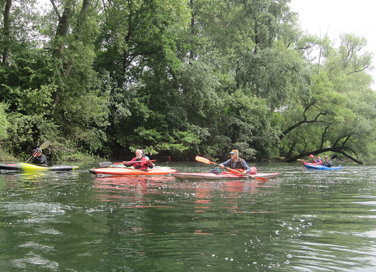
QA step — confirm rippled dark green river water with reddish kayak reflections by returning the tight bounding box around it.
[0,162,376,272]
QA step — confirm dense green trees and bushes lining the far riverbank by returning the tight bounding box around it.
[0,0,376,163]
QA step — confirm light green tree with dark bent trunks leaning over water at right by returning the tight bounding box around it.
[280,35,376,163]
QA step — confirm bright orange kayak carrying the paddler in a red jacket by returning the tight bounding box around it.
[89,167,176,176]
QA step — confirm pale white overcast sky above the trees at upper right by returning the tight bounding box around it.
[290,0,376,90]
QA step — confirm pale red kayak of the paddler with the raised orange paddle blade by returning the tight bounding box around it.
[171,172,280,180]
